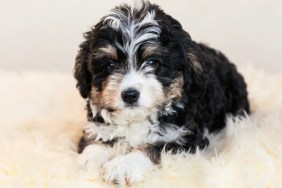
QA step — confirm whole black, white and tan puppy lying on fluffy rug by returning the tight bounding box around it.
[74,1,249,185]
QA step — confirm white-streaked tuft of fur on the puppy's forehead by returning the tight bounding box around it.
[105,3,161,66]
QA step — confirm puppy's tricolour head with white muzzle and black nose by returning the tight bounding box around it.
[74,2,199,120]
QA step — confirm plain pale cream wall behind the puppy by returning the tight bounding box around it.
[0,0,282,72]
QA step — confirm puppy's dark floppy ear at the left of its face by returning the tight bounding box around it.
[74,34,92,98]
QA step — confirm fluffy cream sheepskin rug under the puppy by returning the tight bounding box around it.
[0,67,282,188]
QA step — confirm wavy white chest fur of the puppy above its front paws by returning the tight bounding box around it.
[85,120,189,148]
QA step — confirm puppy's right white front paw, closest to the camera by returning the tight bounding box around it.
[103,151,153,185]
